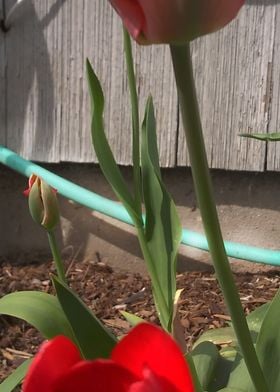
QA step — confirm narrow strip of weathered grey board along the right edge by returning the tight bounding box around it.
[266,4,280,171]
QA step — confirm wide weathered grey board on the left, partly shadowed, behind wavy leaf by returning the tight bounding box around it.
[2,0,177,166]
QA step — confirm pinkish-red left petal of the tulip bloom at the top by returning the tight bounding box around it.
[111,0,145,40]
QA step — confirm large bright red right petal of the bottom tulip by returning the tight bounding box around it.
[112,323,194,392]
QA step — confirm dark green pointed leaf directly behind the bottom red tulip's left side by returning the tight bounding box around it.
[52,276,117,359]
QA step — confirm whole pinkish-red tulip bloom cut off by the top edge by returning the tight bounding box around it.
[110,0,244,44]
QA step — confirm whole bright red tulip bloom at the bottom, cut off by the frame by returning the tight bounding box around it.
[22,323,194,392]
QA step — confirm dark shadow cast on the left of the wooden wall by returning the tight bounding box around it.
[5,0,65,160]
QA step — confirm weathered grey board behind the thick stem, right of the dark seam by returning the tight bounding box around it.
[178,4,275,171]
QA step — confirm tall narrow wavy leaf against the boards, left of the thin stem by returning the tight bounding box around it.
[86,60,142,224]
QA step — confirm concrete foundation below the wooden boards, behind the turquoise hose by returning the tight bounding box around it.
[0,164,280,273]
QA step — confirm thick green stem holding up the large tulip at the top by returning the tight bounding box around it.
[170,44,268,392]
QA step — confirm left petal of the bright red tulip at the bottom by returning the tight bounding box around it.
[22,336,81,392]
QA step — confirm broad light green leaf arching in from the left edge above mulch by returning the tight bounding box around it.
[0,291,73,340]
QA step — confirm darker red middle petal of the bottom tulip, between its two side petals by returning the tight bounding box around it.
[52,359,138,392]
